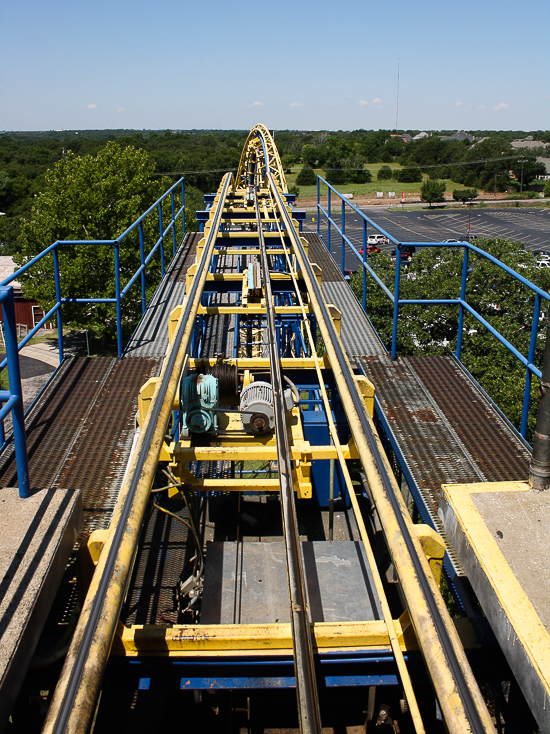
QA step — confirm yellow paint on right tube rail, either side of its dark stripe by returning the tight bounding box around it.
[270,178,494,734]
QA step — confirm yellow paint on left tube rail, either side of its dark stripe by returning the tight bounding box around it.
[43,174,231,734]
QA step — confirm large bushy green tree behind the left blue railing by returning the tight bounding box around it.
[15,142,169,342]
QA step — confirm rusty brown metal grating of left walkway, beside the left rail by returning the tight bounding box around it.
[0,357,159,540]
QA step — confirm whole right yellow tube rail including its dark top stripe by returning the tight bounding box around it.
[268,175,495,734]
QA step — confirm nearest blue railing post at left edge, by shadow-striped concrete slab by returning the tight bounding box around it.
[0,286,31,497]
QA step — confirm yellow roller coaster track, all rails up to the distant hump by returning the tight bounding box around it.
[44,125,494,734]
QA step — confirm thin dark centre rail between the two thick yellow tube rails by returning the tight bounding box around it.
[254,191,321,734]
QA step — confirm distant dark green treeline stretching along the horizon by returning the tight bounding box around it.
[0,130,550,254]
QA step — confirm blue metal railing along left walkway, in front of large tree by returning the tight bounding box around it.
[0,178,185,362]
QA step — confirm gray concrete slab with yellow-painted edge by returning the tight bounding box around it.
[439,482,550,734]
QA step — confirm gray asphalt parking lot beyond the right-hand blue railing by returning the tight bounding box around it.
[304,207,550,270]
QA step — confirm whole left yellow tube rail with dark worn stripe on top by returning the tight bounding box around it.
[43,174,232,734]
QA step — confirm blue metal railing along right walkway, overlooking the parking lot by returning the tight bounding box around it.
[317,176,550,438]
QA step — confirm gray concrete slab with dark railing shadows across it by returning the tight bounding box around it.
[0,487,82,731]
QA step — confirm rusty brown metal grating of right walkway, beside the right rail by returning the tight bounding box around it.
[361,356,529,525]
